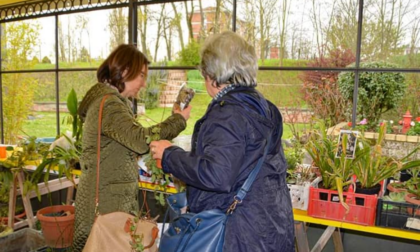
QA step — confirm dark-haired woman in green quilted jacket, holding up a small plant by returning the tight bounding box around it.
[73,44,191,251]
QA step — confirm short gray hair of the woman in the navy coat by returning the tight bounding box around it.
[199,31,258,87]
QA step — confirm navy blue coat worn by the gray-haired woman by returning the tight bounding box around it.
[162,87,294,252]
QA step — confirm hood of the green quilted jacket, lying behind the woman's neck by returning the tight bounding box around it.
[78,83,122,122]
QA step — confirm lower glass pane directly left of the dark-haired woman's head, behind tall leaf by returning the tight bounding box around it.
[59,71,97,136]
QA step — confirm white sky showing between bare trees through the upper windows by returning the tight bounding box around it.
[15,0,420,63]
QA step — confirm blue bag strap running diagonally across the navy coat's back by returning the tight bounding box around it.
[227,131,271,214]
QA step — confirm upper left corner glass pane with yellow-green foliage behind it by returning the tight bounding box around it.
[1,17,55,70]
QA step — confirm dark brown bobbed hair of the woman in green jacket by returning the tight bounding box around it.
[96,44,150,93]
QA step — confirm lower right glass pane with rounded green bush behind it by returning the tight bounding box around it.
[357,72,420,133]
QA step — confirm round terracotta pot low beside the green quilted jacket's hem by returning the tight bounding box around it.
[36,205,75,248]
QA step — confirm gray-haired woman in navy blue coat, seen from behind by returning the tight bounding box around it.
[150,31,294,252]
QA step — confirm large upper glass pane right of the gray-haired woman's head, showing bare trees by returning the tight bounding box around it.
[236,0,358,67]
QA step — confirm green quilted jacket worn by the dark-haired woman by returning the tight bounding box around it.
[73,83,186,251]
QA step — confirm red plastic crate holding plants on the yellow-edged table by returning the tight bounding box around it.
[308,187,378,226]
